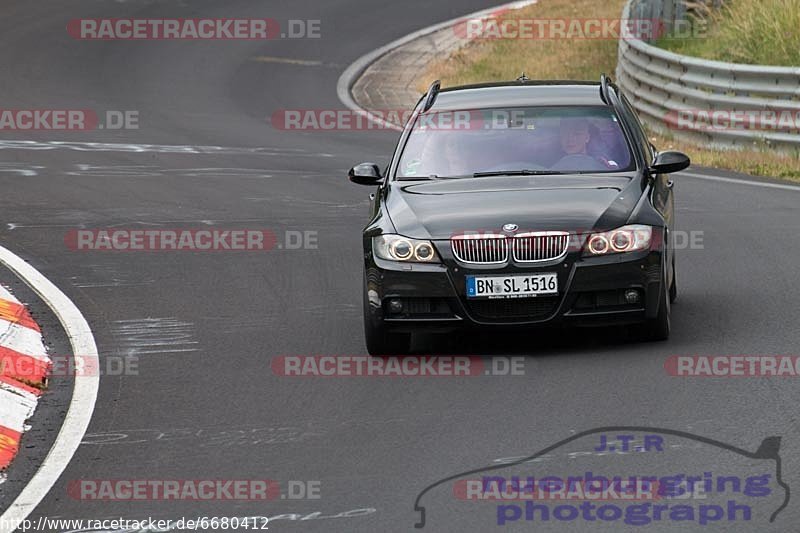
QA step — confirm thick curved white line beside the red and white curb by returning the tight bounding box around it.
[0,246,100,533]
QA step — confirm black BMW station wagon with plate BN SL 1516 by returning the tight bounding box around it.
[349,76,690,355]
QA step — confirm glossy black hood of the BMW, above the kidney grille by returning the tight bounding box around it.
[386,174,641,239]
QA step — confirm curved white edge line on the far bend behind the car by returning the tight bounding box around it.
[336,0,538,131]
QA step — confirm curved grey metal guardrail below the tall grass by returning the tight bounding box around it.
[617,0,800,151]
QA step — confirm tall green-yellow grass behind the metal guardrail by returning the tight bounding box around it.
[657,0,800,67]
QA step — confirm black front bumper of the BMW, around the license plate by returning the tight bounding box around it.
[365,238,666,331]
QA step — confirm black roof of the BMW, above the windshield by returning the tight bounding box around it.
[431,81,606,112]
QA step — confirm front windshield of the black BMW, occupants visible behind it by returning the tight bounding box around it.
[397,106,635,179]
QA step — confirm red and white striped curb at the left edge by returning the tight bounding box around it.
[0,286,51,483]
